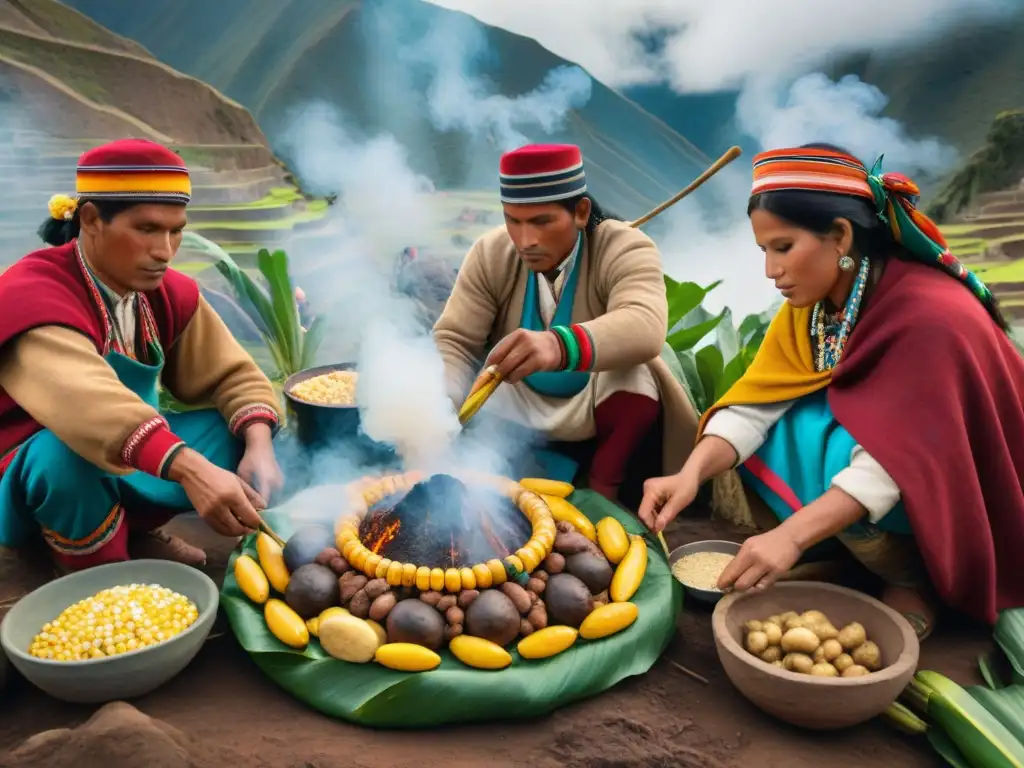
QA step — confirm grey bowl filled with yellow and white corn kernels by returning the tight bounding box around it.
[0,560,219,703]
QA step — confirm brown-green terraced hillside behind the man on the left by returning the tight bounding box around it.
[0,0,326,267]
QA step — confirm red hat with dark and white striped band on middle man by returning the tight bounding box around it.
[500,144,587,205]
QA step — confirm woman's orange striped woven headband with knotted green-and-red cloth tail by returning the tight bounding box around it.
[751,148,995,309]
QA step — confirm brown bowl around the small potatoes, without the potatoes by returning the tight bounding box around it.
[712,582,921,730]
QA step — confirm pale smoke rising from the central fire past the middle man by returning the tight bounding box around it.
[264,4,591,507]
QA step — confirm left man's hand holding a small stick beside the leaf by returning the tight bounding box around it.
[168,447,266,537]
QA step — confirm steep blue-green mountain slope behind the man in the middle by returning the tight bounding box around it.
[59,0,710,217]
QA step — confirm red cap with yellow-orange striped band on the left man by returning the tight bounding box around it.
[76,138,191,203]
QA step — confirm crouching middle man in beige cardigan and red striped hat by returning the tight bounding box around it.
[434,145,696,500]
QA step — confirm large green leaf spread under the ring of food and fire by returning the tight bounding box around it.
[221,490,682,729]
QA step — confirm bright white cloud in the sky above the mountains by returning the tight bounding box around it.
[421,0,1020,92]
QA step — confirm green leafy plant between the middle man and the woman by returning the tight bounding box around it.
[665,276,773,413]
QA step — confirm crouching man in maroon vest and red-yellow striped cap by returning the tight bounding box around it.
[0,139,282,570]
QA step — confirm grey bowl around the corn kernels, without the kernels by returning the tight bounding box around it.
[0,560,219,703]
